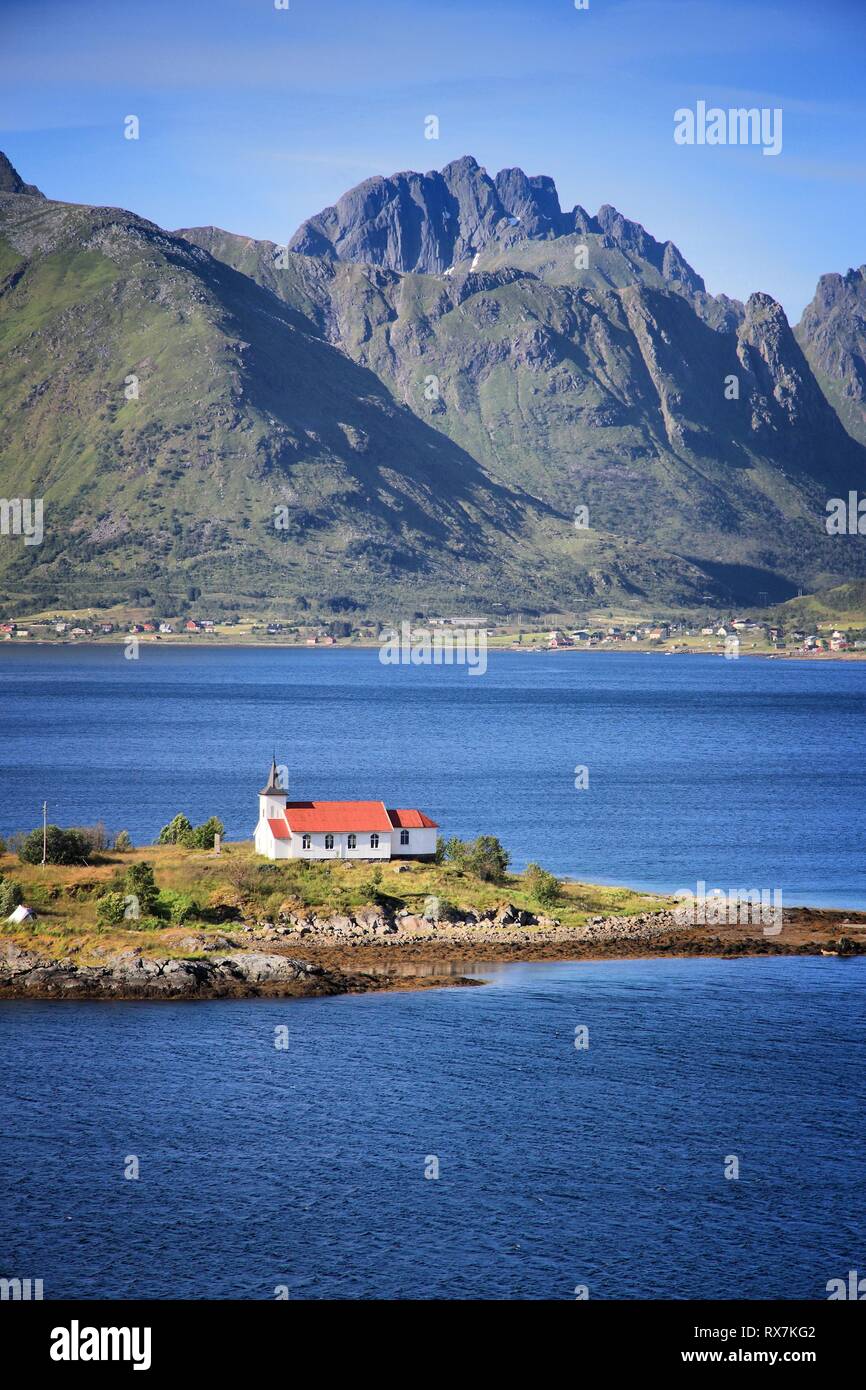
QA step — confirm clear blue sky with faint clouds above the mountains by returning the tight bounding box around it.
[0,0,866,321]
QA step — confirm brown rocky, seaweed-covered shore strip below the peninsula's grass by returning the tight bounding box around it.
[0,904,866,999]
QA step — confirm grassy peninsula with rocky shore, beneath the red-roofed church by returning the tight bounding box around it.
[0,842,866,998]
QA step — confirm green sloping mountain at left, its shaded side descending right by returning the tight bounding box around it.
[0,152,705,614]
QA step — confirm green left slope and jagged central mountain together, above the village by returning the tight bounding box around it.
[0,148,866,617]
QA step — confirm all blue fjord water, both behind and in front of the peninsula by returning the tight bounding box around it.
[0,646,866,1298]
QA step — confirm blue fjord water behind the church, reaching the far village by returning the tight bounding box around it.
[0,642,866,908]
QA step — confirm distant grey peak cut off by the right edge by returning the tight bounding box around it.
[795,265,866,443]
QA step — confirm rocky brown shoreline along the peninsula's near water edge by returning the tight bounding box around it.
[0,909,866,1002]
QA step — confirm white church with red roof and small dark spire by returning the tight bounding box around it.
[256,760,439,859]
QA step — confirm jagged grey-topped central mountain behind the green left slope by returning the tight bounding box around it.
[182,160,866,602]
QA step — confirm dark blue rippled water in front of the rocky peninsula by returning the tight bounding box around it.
[0,958,866,1300]
